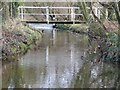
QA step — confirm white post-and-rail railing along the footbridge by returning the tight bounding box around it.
[18,6,102,23]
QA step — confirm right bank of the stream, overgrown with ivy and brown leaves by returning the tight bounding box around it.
[58,21,120,63]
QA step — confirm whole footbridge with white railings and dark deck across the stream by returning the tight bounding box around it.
[18,6,104,24]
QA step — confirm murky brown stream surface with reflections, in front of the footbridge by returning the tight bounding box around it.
[2,31,120,88]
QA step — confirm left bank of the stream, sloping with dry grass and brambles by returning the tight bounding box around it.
[2,20,42,62]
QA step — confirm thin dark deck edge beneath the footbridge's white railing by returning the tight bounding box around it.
[22,21,86,24]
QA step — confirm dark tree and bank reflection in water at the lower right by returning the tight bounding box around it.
[74,62,120,88]
